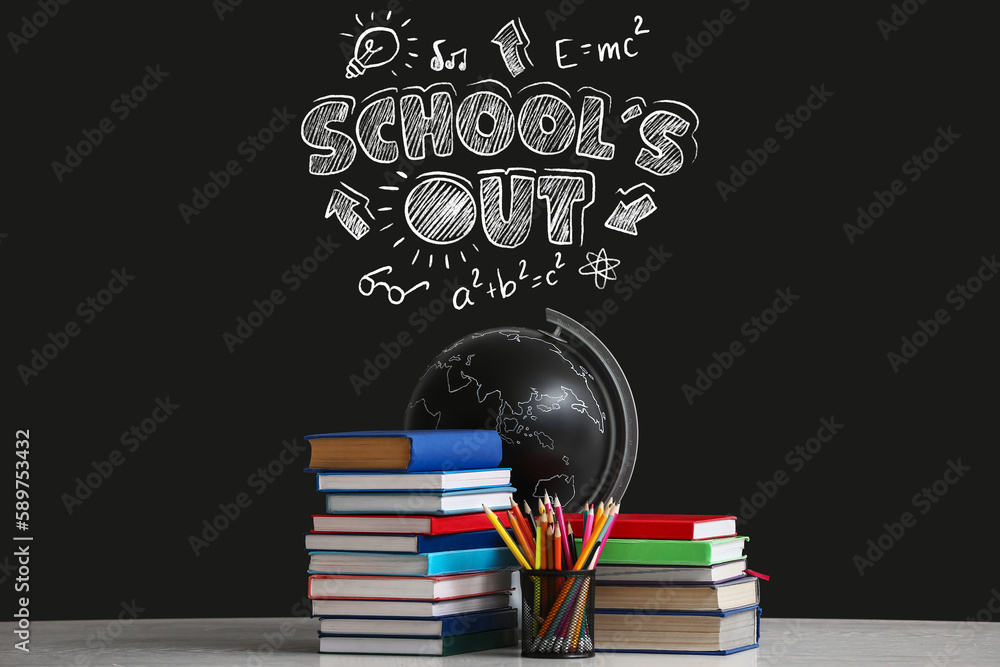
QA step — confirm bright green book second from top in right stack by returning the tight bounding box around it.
[577,536,750,567]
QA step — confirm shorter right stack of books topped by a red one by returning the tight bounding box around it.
[566,514,760,654]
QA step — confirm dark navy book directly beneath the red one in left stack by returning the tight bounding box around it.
[306,529,505,554]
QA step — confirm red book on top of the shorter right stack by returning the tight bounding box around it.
[564,514,736,540]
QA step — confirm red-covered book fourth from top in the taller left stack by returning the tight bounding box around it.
[312,512,510,535]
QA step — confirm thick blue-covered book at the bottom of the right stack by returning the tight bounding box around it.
[594,605,760,655]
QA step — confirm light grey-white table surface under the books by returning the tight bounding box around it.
[0,617,1000,667]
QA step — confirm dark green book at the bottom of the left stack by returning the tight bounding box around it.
[319,628,520,655]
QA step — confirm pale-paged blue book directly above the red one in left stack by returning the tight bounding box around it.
[325,486,516,515]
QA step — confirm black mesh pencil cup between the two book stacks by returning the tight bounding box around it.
[521,570,594,658]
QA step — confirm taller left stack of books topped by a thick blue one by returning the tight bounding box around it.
[305,430,518,655]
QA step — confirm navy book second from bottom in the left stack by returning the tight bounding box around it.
[319,607,517,637]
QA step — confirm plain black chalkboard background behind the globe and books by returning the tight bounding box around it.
[0,0,1000,620]
